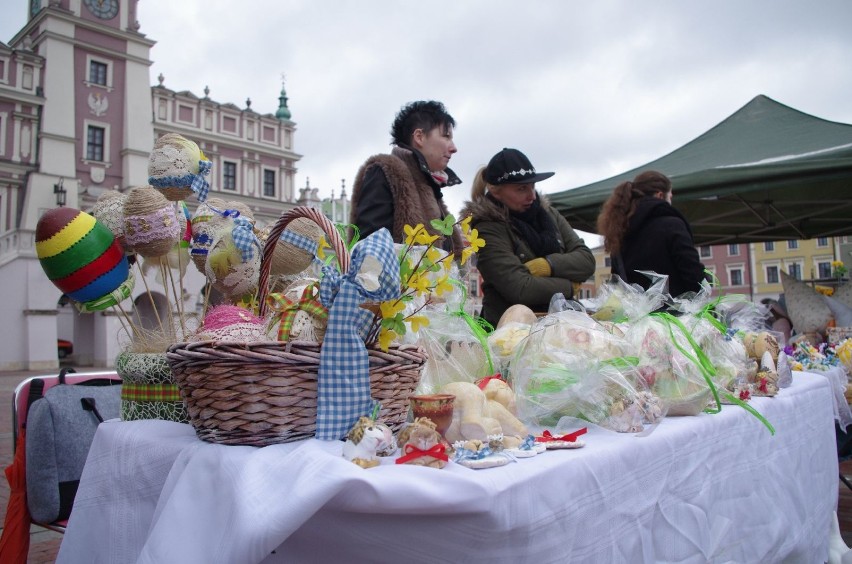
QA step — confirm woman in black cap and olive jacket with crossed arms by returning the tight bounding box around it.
[461,149,595,325]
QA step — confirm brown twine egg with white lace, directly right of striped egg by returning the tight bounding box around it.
[124,186,180,257]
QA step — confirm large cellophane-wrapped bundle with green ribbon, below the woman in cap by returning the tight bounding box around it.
[512,311,664,432]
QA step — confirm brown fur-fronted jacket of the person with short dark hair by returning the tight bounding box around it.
[350,147,464,253]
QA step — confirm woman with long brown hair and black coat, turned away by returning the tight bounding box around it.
[597,170,705,296]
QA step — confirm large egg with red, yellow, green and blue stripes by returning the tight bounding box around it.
[36,207,130,302]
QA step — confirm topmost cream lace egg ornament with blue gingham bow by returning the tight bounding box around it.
[148,133,211,202]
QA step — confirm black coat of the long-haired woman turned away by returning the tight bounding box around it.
[612,196,705,296]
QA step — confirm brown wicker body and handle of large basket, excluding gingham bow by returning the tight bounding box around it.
[166,207,426,446]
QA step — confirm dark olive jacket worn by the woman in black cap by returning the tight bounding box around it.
[461,194,595,325]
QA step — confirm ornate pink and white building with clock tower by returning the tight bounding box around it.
[0,0,304,370]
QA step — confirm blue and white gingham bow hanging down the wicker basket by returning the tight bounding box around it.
[316,229,400,441]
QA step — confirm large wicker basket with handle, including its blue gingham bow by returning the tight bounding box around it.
[166,207,426,446]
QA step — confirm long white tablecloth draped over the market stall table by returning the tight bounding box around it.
[57,372,838,564]
